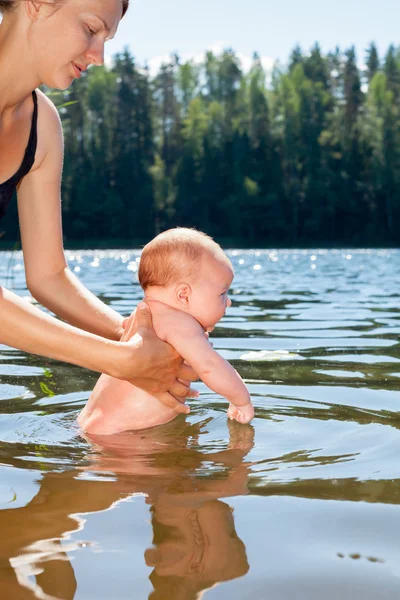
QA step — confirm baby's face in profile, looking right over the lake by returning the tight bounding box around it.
[189,256,234,329]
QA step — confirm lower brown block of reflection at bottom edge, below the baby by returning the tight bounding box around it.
[145,500,249,600]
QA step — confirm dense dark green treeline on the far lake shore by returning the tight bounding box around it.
[2,44,400,246]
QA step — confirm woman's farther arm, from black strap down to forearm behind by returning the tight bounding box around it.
[18,92,122,340]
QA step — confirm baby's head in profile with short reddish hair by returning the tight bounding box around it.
[138,227,234,329]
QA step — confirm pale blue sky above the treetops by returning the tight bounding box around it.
[106,0,400,72]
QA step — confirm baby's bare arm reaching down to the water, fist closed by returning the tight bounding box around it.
[166,315,254,423]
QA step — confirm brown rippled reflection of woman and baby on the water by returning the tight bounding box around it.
[0,422,254,600]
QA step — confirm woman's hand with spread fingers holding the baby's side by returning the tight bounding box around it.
[115,302,198,414]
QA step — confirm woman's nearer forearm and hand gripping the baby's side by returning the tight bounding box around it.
[0,287,192,412]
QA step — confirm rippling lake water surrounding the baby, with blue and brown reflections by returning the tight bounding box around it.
[0,250,400,600]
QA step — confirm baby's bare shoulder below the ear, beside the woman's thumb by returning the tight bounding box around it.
[146,299,204,341]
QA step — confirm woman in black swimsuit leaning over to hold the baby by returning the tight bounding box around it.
[0,0,196,412]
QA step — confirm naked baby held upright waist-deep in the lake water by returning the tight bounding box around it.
[78,228,254,434]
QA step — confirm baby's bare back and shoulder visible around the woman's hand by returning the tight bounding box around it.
[78,300,193,434]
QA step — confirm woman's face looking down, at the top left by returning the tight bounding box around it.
[30,0,122,90]
